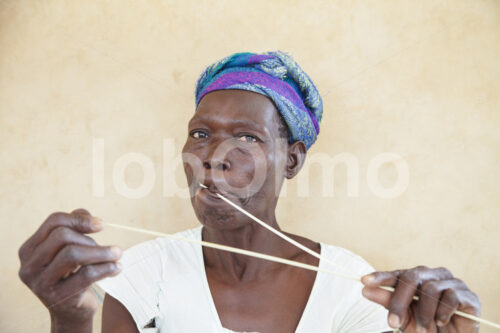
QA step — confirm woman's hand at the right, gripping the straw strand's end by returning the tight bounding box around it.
[361,266,481,333]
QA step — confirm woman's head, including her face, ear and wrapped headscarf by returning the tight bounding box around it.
[183,52,322,228]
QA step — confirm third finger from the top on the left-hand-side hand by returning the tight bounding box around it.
[43,245,122,284]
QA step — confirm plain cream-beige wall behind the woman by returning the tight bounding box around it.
[0,0,500,332]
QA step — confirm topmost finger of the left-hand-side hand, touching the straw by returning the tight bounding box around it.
[19,209,102,262]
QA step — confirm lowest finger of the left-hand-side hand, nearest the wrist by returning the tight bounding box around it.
[47,262,122,308]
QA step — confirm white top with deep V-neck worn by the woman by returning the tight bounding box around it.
[97,226,391,333]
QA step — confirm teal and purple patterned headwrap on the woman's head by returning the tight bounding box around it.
[195,51,323,149]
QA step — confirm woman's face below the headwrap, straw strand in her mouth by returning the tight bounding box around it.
[182,90,288,229]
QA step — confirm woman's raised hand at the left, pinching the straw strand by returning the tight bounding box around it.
[19,209,122,331]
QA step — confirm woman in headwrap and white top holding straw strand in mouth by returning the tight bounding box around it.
[19,52,480,332]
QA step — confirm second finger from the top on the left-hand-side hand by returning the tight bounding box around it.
[26,227,97,270]
